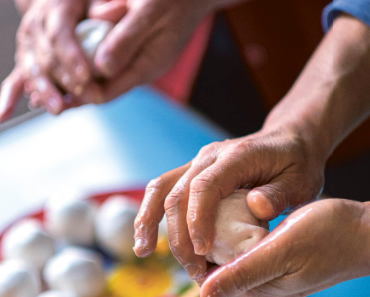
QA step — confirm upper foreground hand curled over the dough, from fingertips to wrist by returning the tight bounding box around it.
[135,129,325,279]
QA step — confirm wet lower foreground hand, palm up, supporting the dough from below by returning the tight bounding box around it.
[201,199,370,297]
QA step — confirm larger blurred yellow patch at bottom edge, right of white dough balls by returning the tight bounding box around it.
[109,263,172,297]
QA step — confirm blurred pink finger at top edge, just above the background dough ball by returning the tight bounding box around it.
[88,0,127,23]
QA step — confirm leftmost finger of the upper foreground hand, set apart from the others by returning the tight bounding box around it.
[134,163,191,257]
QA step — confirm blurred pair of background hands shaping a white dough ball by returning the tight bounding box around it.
[0,0,212,121]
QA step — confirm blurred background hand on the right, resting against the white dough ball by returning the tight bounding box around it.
[91,0,211,102]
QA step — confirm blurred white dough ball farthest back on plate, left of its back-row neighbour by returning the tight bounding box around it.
[45,189,97,245]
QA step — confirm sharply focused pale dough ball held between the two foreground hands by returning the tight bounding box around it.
[206,190,269,265]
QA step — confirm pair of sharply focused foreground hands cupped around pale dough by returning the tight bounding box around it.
[134,129,369,297]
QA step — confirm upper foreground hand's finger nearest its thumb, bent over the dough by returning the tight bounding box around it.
[187,157,249,255]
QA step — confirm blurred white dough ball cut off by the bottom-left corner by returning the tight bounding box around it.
[0,260,41,297]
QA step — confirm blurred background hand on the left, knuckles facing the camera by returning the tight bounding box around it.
[0,0,101,120]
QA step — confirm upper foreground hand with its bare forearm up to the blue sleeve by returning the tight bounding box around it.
[135,15,370,290]
